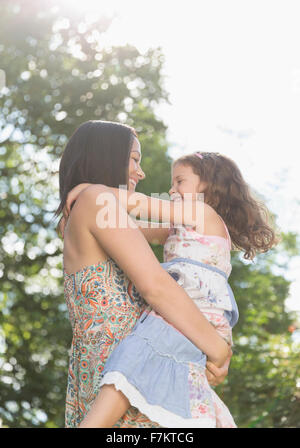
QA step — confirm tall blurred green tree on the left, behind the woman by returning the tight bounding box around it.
[0,1,170,427]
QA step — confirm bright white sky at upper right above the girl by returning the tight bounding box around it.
[52,0,300,310]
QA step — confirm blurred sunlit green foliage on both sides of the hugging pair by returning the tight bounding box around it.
[0,0,300,427]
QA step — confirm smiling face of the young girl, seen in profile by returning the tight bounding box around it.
[169,163,206,200]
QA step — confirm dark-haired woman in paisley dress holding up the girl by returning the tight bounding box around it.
[56,121,229,427]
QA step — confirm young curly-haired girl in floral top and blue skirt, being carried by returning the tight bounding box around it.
[61,152,276,428]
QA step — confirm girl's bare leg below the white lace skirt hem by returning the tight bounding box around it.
[79,384,130,428]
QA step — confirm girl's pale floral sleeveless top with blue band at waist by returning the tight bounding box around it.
[162,218,239,334]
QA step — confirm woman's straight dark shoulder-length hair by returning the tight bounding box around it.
[54,120,137,236]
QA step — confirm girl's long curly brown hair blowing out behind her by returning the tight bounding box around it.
[173,152,280,260]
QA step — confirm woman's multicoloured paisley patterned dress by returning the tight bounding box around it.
[64,259,159,428]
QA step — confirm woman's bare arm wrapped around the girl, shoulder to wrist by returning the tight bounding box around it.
[72,185,230,367]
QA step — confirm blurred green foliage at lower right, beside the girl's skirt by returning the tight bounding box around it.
[216,233,300,428]
